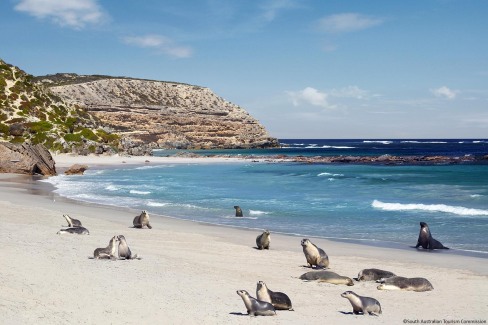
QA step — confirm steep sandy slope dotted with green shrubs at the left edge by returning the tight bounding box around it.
[0,60,119,154]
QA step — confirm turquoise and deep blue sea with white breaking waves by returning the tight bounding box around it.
[44,139,488,257]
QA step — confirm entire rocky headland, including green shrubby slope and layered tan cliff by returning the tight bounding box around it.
[0,60,279,155]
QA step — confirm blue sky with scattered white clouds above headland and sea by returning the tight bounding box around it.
[0,0,488,138]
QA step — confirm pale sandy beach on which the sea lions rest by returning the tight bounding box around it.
[0,155,488,324]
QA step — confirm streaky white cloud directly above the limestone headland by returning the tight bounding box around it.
[123,35,192,58]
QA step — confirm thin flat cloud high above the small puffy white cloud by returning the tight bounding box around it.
[318,13,383,33]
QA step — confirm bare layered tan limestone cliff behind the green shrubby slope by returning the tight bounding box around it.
[43,74,279,154]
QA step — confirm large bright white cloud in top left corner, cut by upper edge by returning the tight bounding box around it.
[14,0,106,29]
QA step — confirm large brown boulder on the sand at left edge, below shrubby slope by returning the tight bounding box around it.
[0,142,56,176]
